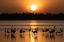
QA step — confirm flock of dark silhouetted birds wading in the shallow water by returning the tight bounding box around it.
[5,26,63,35]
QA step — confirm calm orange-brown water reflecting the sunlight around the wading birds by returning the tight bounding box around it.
[0,20,64,42]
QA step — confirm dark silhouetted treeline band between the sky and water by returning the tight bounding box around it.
[0,12,64,20]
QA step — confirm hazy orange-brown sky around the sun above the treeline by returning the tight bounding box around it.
[0,0,64,13]
